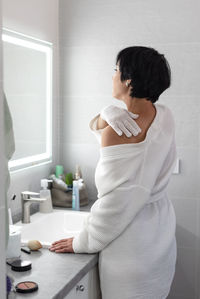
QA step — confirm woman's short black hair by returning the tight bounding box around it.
[116,46,171,103]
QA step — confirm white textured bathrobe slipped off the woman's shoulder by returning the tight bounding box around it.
[72,104,177,299]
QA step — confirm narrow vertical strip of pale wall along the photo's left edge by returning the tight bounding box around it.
[0,0,6,299]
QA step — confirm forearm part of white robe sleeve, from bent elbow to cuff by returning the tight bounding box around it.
[72,184,150,253]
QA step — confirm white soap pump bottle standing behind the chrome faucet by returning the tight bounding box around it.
[40,179,53,213]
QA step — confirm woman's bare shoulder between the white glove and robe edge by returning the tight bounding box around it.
[101,126,145,147]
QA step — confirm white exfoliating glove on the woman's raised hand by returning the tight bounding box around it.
[100,105,142,137]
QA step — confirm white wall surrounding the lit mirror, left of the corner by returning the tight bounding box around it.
[3,0,60,215]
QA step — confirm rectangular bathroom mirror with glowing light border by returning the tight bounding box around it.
[2,29,52,171]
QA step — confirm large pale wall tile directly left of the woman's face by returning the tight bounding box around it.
[61,44,119,97]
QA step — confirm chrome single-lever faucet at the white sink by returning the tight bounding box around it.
[21,191,46,223]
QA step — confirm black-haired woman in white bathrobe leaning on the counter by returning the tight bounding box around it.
[50,47,177,299]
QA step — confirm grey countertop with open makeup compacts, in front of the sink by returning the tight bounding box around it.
[7,245,98,299]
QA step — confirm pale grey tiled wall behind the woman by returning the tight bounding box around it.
[59,0,200,299]
